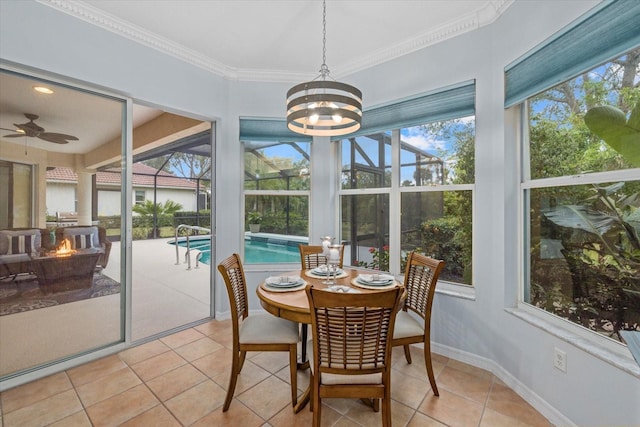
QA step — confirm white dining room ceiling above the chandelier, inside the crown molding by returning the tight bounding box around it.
[58,0,513,81]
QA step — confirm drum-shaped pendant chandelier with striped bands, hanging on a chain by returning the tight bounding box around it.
[287,0,362,136]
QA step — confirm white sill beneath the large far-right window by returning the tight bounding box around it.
[505,308,640,378]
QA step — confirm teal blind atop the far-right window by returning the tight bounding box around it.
[505,0,640,107]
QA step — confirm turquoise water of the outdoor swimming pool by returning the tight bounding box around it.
[168,236,300,264]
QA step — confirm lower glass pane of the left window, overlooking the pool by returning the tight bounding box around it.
[244,195,309,264]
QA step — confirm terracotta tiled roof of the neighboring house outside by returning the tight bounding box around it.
[47,163,197,190]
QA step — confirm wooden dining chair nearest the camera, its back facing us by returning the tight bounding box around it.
[305,285,401,427]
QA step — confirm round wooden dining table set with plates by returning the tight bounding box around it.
[256,268,402,413]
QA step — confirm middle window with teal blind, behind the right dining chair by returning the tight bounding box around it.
[340,83,475,285]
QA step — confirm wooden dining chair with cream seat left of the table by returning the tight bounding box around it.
[218,254,299,412]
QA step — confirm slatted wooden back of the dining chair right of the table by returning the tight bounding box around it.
[403,252,445,318]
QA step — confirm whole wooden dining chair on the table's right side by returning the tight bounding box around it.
[391,252,445,396]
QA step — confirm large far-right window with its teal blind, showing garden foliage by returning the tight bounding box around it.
[506,2,640,341]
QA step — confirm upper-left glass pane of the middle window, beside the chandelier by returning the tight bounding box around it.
[341,132,391,189]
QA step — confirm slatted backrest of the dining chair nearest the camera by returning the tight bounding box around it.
[306,286,401,374]
